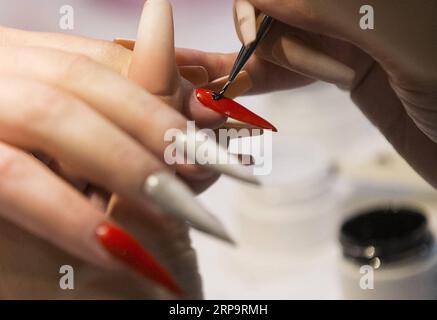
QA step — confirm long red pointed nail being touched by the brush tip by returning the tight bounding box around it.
[196,89,278,132]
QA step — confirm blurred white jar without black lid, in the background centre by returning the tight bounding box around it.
[238,139,340,257]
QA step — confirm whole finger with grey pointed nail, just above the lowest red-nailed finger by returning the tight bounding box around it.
[0,77,235,240]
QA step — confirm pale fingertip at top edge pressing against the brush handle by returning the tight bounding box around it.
[234,0,256,46]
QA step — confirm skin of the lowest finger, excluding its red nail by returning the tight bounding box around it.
[0,143,108,267]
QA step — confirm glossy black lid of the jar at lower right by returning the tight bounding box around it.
[340,207,434,267]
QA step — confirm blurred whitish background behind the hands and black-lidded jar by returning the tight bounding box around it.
[0,0,437,299]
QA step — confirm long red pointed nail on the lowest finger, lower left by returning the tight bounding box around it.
[96,222,182,296]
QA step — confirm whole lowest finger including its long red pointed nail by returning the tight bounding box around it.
[0,143,180,293]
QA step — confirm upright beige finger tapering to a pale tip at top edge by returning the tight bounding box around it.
[129,0,179,97]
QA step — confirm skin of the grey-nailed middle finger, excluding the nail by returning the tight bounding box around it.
[0,77,162,199]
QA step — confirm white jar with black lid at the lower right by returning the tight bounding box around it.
[340,207,437,299]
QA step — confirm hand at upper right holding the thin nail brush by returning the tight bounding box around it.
[177,0,437,187]
